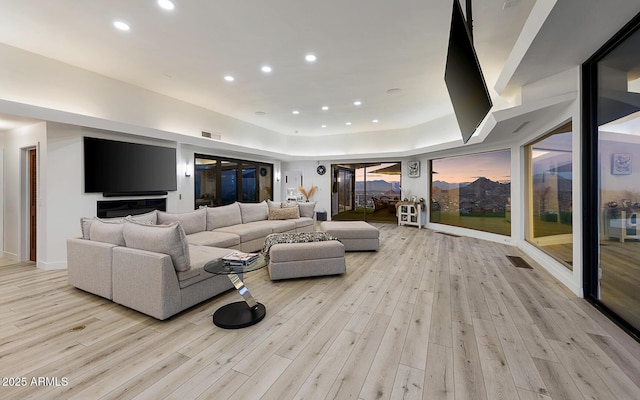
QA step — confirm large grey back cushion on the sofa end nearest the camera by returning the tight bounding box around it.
[123,221,191,271]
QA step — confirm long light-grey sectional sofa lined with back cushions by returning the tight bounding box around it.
[67,202,315,320]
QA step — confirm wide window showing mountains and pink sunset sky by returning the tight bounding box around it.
[431,150,511,235]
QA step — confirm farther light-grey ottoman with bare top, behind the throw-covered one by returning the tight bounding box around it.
[320,221,380,251]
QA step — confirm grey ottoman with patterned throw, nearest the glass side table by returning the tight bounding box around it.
[267,240,347,281]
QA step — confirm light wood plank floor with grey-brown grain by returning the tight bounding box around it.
[0,224,640,400]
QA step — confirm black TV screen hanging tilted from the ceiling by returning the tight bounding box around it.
[444,0,493,143]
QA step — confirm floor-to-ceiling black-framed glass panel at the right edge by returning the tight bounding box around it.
[583,12,640,338]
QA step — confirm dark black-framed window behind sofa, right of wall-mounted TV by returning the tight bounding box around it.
[195,154,273,208]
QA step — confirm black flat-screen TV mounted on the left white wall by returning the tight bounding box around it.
[84,137,177,196]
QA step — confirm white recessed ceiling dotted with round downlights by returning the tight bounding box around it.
[0,0,535,136]
